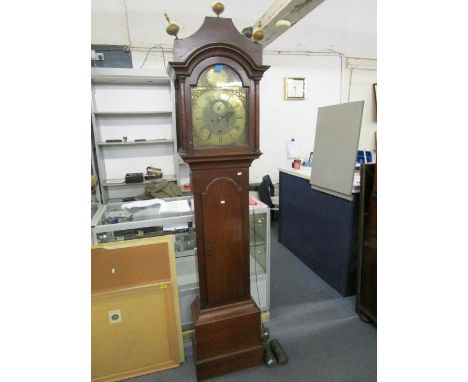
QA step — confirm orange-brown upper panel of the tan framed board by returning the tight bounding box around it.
[91,239,171,294]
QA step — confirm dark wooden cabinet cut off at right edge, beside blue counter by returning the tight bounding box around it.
[356,164,377,323]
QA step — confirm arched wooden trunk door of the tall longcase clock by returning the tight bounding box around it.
[202,177,248,305]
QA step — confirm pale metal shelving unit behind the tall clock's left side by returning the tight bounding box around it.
[91,68,188,203]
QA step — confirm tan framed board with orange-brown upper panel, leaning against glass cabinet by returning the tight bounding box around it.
[91,236,184,382]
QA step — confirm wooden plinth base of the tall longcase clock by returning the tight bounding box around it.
[192,297,263,381]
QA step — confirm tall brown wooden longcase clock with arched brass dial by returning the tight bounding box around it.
[169,17,268,380]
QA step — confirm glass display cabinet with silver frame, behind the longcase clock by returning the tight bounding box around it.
[91,196,270,330]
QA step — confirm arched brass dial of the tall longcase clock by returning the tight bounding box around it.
[191,65,247,147]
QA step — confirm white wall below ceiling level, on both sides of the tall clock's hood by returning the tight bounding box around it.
[98,49,377,183]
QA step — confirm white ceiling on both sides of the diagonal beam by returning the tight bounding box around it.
[91,0,377,58]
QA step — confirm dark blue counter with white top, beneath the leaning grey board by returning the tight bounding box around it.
[278,169,359,296]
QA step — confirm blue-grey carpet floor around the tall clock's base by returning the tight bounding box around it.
[127,224,377,382]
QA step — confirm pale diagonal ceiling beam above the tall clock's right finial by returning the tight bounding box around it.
[253,0,325,47]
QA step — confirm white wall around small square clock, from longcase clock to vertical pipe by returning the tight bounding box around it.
[250,54,341,182]
